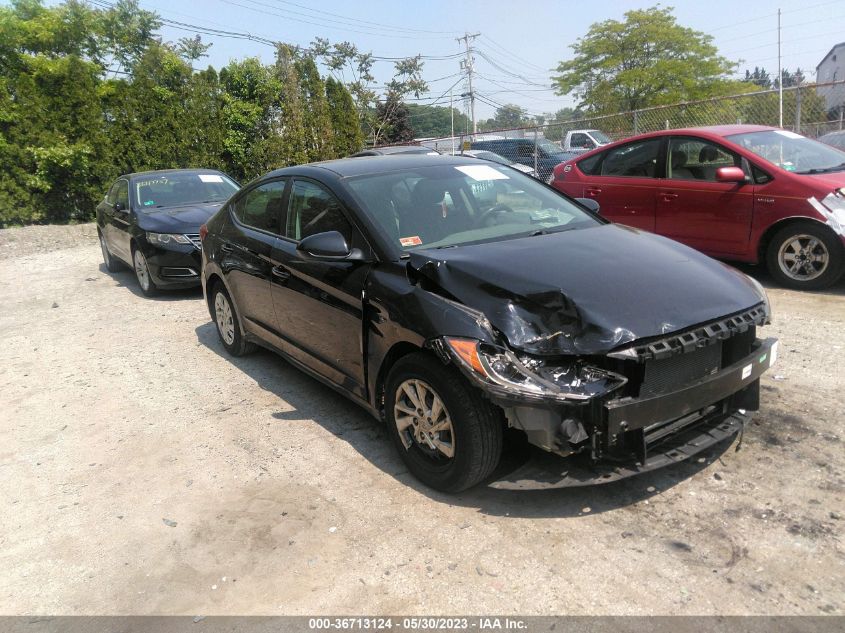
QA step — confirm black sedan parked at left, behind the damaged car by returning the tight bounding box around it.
[97,169,238,296]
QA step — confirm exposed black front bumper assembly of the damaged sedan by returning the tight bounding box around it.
[493,338,777,489]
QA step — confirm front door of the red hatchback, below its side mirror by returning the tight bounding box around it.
[655,136,754,257]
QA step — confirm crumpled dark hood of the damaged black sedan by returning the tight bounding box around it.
[409,224,765,354]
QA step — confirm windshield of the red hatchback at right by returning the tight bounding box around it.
[727,130,845,174]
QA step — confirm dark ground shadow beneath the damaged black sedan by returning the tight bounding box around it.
[195,322,731,518]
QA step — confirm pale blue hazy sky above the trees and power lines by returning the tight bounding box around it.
[39,0,845,120]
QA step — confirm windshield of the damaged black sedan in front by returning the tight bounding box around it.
[348,163,601,251]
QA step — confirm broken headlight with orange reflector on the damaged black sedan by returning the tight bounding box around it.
[442,337,627,400]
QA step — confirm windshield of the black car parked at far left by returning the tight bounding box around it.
[135,172,239,209]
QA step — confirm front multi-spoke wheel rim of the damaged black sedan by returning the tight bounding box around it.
[393,379,455,460]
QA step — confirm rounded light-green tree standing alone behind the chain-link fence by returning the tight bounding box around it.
[552,6,738,114]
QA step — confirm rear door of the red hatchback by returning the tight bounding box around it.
[567,138,662,231]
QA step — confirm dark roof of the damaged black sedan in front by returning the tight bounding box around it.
[262,154,478,180]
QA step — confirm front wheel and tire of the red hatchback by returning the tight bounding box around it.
[766,222,843,290]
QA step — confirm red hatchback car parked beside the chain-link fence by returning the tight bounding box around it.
[551,125,845,289]
